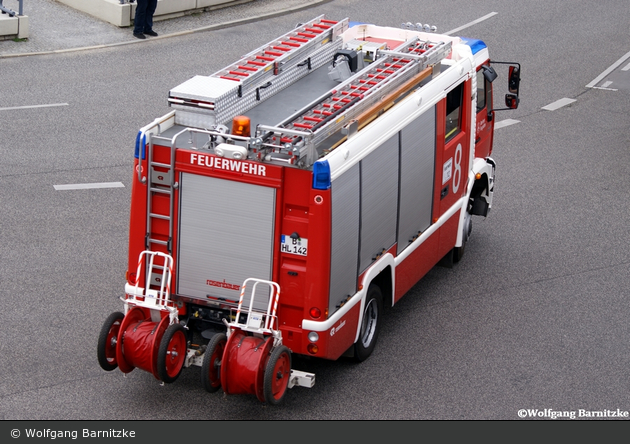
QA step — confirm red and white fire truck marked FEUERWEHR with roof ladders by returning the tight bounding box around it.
[98,16,520,404]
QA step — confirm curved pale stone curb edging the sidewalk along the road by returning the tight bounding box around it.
[0,0,332,59]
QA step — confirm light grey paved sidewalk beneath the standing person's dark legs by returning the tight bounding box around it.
[0,0,330,58]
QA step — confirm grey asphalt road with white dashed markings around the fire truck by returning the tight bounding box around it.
[0,0,630,420]
